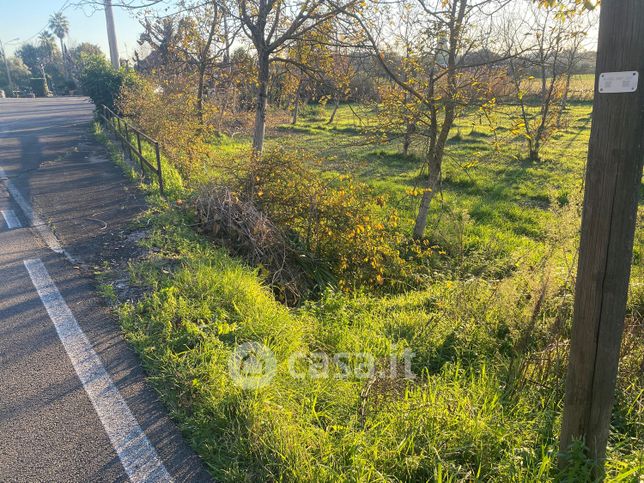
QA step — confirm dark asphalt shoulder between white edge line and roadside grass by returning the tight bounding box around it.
[24,116,209,481]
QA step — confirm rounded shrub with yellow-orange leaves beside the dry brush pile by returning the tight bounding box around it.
[219,148,431,290]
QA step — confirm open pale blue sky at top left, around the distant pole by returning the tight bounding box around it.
[0,0,151,58]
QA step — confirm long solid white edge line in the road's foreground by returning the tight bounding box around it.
[24,259,171,482]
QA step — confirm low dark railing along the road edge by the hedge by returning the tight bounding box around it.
[98,105,164,195]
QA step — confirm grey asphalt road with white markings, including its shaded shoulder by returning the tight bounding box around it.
[0,97,209,482]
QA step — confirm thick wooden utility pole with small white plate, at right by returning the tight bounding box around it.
[560,0,644,468]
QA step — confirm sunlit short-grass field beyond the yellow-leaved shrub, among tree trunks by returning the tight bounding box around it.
[208,103,591,276]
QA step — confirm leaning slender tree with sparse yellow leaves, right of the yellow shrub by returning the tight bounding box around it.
[349,0,509,238]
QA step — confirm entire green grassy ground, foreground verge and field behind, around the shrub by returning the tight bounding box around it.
[93,99,644,482]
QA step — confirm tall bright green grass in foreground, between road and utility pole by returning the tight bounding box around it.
[103,205,641,481]
